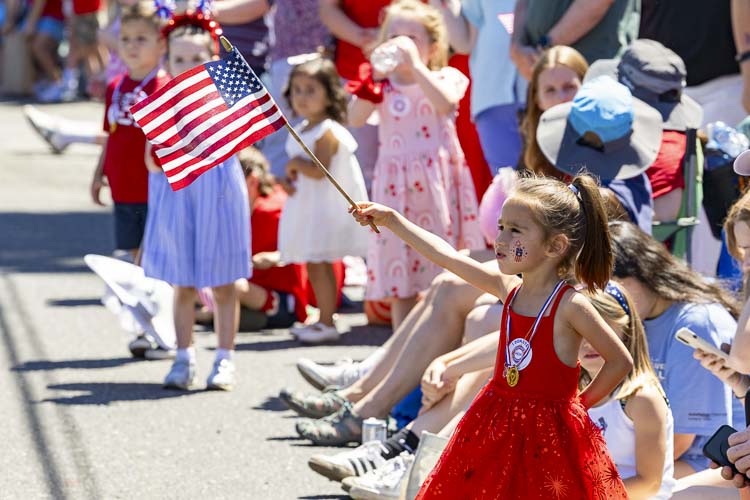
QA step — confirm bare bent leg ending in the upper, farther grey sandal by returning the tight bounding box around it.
[341,273,482,402]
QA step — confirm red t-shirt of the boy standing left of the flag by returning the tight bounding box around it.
[104,71,169,203]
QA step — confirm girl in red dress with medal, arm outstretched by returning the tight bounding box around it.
[354,175,633,499]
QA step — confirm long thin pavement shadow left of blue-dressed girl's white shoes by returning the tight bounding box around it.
[41,382,206,405]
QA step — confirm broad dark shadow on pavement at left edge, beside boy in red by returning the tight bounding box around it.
[0,211,114,273]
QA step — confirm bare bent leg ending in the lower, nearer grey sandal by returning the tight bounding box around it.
[354,287,499,418]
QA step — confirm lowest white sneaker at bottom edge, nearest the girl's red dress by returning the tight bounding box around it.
[347,452,414,500]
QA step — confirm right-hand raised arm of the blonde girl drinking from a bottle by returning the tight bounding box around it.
[389,36,465,115]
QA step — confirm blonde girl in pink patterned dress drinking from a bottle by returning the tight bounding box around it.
[348,0,485,328]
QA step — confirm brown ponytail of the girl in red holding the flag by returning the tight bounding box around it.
[570,175,614,291]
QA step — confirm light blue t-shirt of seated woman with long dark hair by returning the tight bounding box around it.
[643,302,737,471]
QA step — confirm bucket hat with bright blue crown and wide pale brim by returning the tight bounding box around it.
[536,76,662,181]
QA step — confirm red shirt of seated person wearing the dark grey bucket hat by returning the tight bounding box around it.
[646,130,687,199]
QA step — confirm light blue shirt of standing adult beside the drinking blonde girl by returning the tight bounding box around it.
[461,0,526,117]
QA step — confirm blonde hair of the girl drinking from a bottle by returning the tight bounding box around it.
[380,0,448,70]
